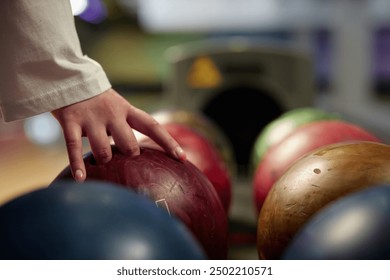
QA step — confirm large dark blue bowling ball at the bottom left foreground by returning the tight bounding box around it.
[0,181,206,260]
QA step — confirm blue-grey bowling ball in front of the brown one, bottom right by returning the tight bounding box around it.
[283,184,390,260]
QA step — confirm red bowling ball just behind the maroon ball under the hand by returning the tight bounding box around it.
[139,123,232,214]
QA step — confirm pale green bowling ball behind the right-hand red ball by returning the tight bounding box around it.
[250,107,341,171]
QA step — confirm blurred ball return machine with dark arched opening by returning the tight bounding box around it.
[164,37,315,172]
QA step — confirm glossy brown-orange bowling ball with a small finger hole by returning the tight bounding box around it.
[257,141,390,259]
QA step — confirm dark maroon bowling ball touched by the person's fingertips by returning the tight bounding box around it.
[54,145,228,259]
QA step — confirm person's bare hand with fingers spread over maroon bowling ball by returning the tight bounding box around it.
[52,89,186,182]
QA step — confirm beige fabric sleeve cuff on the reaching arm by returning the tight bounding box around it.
[0,0,111,122]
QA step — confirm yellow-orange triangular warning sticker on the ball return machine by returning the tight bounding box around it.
[187,56,222,88]
